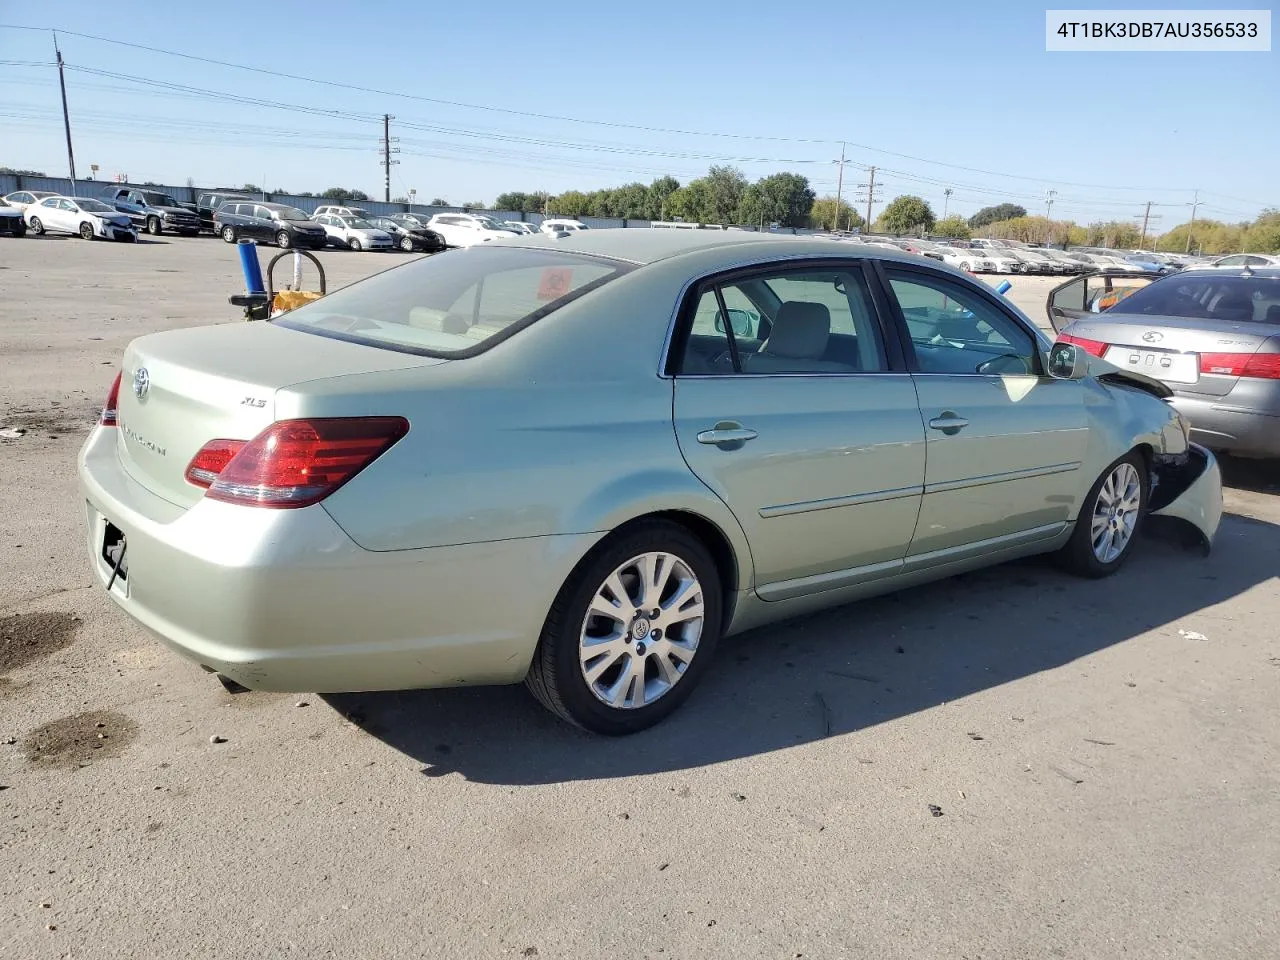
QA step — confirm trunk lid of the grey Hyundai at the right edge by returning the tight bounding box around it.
[1066,314,1280,397]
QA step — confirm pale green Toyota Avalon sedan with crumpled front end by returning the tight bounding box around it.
[79,229,1221,733]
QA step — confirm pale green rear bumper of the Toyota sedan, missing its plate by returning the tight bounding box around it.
[78,428,596,692]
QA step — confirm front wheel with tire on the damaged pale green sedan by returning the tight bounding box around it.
[1059,451,1151,579]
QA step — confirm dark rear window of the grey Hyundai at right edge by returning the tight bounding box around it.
[1106,275,1280,323]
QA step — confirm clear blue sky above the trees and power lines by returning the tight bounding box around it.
[0,0,1280,229]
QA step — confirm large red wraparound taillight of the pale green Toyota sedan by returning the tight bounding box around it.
[200,417,408,508]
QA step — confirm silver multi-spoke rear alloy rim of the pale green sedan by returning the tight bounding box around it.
[579,553,705,709]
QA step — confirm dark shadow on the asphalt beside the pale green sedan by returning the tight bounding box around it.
[323,515,1280,785]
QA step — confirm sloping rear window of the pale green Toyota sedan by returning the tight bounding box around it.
[274,247,631,357]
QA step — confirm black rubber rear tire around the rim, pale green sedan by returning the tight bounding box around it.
[541,524,723,736]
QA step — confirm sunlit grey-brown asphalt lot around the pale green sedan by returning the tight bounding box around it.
[0,238,1280,960]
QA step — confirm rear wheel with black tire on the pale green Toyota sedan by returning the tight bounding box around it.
[525,521,722,736]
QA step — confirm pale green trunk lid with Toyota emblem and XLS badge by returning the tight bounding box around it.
[116,323,447,506]
